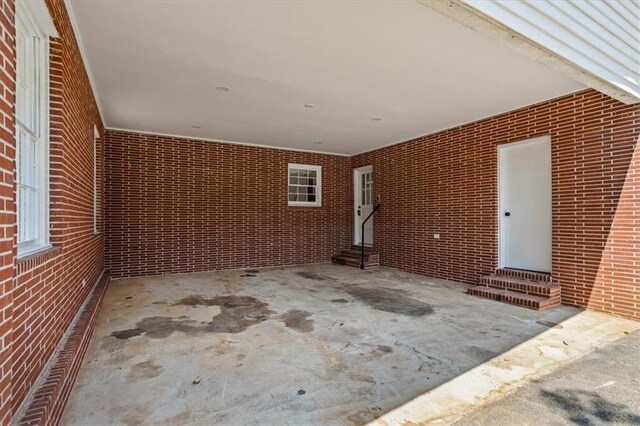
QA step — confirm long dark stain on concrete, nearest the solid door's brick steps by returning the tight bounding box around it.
[345,286,433,317]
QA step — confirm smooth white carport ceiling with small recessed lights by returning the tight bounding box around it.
[69,0,584,154]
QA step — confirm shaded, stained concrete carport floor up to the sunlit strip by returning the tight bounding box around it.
[62,264,624,425]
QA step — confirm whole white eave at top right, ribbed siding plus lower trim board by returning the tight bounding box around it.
[422,0,640,104]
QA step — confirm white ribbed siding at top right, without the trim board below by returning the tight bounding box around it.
[463,0,640,100]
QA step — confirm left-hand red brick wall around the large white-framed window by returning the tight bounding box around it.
[0,0,104,424]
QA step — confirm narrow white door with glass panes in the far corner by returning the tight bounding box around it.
[353,166,374,245]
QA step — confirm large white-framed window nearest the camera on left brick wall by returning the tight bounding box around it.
[16,2,49,256]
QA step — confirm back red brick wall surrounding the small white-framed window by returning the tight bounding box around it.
[106,130,352,277]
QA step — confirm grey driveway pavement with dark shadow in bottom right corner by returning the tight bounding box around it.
[456,331,640,426]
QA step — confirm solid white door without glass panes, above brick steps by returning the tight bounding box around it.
[498,136,551,272]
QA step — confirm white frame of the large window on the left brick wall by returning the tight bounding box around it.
[15,2,51,257]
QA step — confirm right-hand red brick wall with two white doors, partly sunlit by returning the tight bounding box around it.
[352,90,640,319]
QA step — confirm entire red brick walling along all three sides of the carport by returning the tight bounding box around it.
[0,0,640,424]
